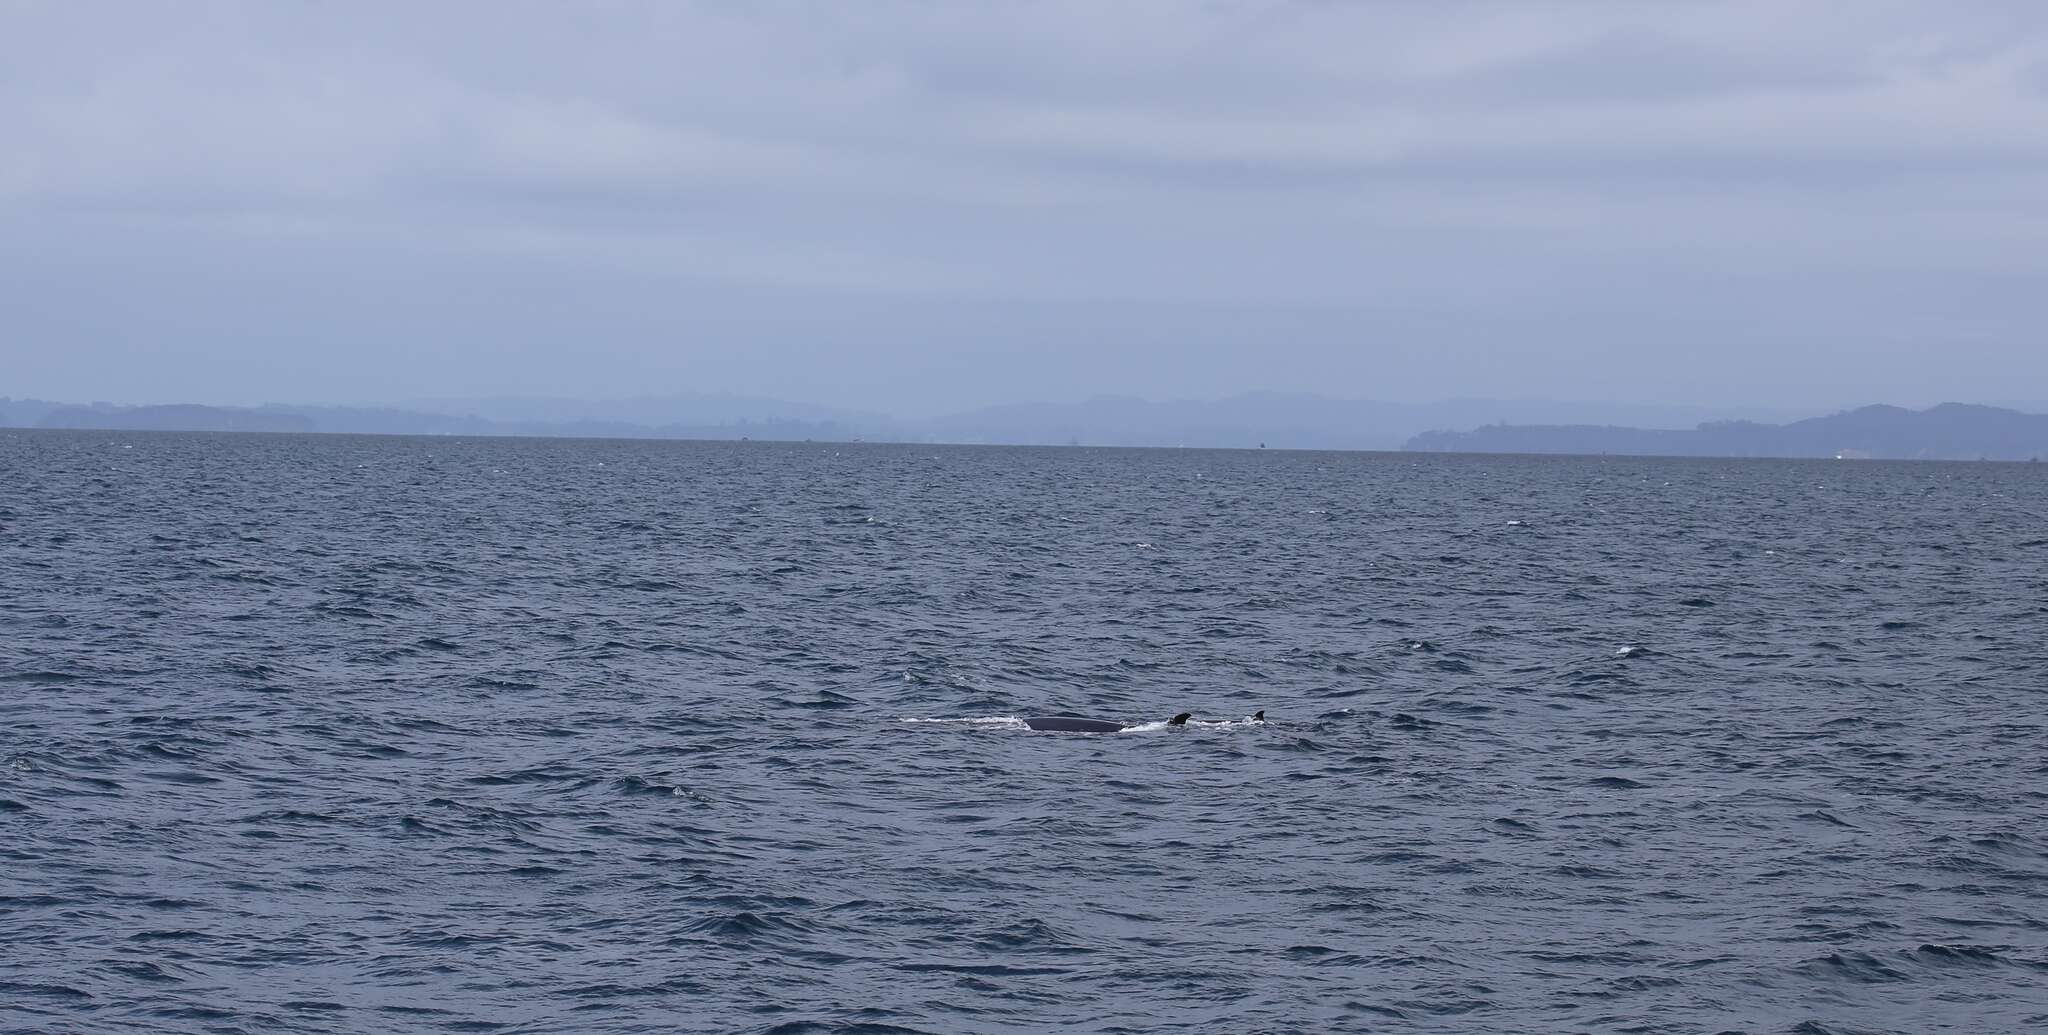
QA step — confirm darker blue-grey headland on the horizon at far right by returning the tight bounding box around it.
[1405,402,2048,459]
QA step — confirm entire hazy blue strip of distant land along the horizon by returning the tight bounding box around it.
[0,394,2048,459]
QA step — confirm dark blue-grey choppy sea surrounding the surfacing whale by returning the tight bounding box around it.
[0,432,2048,1033]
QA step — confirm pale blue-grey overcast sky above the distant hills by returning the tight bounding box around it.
[0,0,2048,414]
